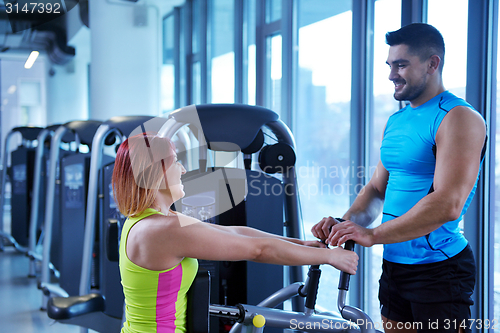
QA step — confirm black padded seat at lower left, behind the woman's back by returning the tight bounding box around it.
[47,293,105,320]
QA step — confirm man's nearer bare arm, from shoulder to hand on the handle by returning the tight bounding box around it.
[328,106,486,246]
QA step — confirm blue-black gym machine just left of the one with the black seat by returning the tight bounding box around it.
[38,120,101,309]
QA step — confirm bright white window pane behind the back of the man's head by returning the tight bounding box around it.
[427,0,469,98]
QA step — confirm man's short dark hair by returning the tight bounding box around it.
[385,23,444,71]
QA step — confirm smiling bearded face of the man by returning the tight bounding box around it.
[387,44,428,102]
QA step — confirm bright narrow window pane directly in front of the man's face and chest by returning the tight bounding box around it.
[365,0,401,323]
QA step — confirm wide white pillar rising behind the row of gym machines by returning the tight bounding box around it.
[89,1,161,120]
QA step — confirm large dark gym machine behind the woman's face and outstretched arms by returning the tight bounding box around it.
[159,104,303,332]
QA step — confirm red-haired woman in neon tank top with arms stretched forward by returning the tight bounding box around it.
[112,133,358,333]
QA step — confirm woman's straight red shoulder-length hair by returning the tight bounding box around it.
[111,133,176,216]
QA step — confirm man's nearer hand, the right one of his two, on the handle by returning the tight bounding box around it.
[328,219,375,247]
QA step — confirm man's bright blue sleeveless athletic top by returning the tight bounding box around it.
[380,91,479,264]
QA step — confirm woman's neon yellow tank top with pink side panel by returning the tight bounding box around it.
[120,208,198,333]
